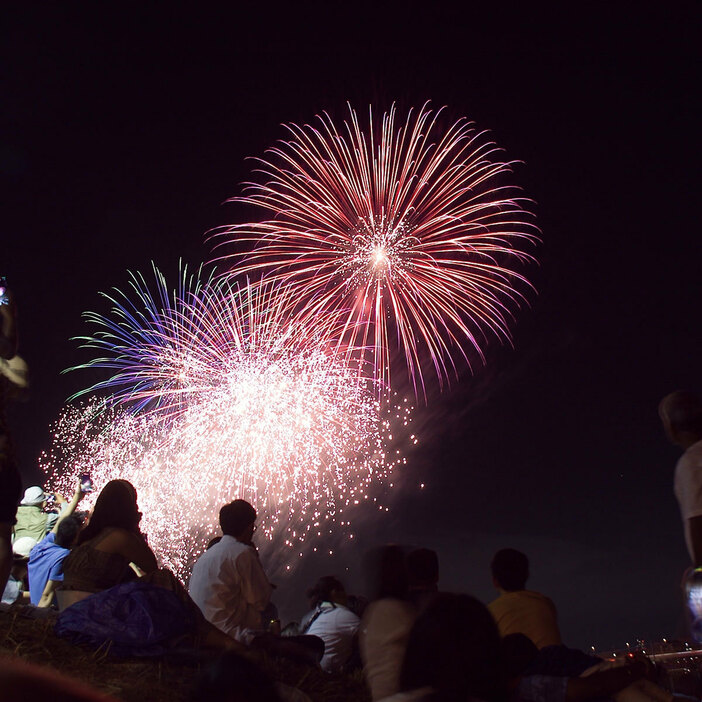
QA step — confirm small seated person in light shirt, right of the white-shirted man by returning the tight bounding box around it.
[300,575,361,673]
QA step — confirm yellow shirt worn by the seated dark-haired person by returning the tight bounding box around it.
[488,590,561,648]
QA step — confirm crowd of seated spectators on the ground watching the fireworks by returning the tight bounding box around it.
[1,480,692,702]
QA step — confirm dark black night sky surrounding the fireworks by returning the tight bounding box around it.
[0,3,702,647]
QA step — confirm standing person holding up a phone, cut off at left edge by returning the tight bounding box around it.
[0,277,26,591]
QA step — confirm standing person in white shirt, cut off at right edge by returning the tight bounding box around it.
[658,391,702,567]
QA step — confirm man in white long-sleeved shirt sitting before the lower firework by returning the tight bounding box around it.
[189,500,273,644]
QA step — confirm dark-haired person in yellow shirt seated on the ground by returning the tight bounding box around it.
[488,548,561,648]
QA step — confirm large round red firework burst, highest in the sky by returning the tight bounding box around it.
[217,105,537,396]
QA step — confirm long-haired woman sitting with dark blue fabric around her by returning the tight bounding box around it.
[56,480,239,655]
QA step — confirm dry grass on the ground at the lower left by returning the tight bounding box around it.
[0,607,370,702]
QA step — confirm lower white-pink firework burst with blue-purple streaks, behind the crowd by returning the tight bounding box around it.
[62,271,410,573]
